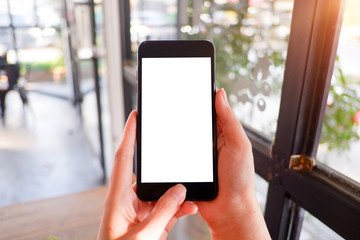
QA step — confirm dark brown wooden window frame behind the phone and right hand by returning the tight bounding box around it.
[120,0,360,239]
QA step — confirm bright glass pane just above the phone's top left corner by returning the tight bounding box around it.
[130,0,177,53]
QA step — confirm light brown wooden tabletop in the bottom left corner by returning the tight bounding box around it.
[0,186,107,240]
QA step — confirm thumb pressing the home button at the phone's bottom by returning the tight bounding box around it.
[144,184,186,239]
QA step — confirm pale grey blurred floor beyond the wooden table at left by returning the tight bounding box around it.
[0,88,102,206]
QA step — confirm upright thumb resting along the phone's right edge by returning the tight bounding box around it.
[215,89,248,148]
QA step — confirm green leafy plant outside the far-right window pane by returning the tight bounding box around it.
[320,56,360,152]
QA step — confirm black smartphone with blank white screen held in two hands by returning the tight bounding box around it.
[136,40,218,201]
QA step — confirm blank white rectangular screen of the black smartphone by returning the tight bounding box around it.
[141,57,214,183]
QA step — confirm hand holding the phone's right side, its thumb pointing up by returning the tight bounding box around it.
[197,89,270,239]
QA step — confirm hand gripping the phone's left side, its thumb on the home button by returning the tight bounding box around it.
[98,111,197,240]
